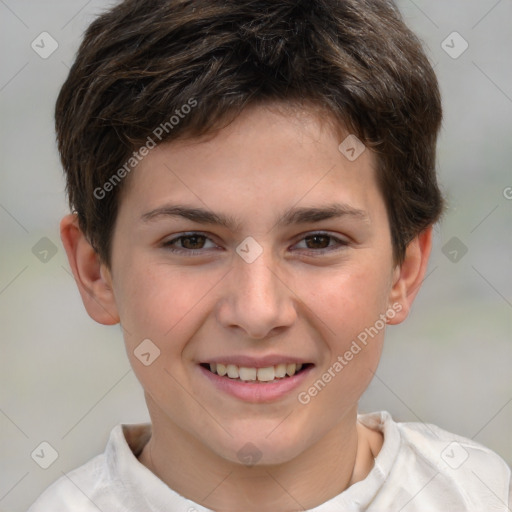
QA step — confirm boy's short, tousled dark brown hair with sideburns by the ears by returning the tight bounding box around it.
[55,0,443,264]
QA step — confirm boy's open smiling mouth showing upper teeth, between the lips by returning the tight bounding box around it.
[200,362,313,384]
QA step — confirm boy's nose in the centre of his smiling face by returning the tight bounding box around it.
[217,253,297,340]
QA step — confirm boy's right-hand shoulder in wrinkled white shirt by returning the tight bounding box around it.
[359,411,511,512]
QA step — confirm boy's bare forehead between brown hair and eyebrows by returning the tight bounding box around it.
[116,106,378,220]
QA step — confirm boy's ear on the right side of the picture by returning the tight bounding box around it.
[387,226,433,324]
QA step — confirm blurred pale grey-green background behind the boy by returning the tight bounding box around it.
[0,0,512,512]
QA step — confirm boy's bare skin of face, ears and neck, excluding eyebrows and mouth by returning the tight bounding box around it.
[61,102,432,512]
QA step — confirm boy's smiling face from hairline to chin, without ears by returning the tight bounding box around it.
[105,107,400,463]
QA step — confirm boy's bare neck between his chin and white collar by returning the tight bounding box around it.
[140,411,382,512]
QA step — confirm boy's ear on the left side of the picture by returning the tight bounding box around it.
[60,214,119,325]
